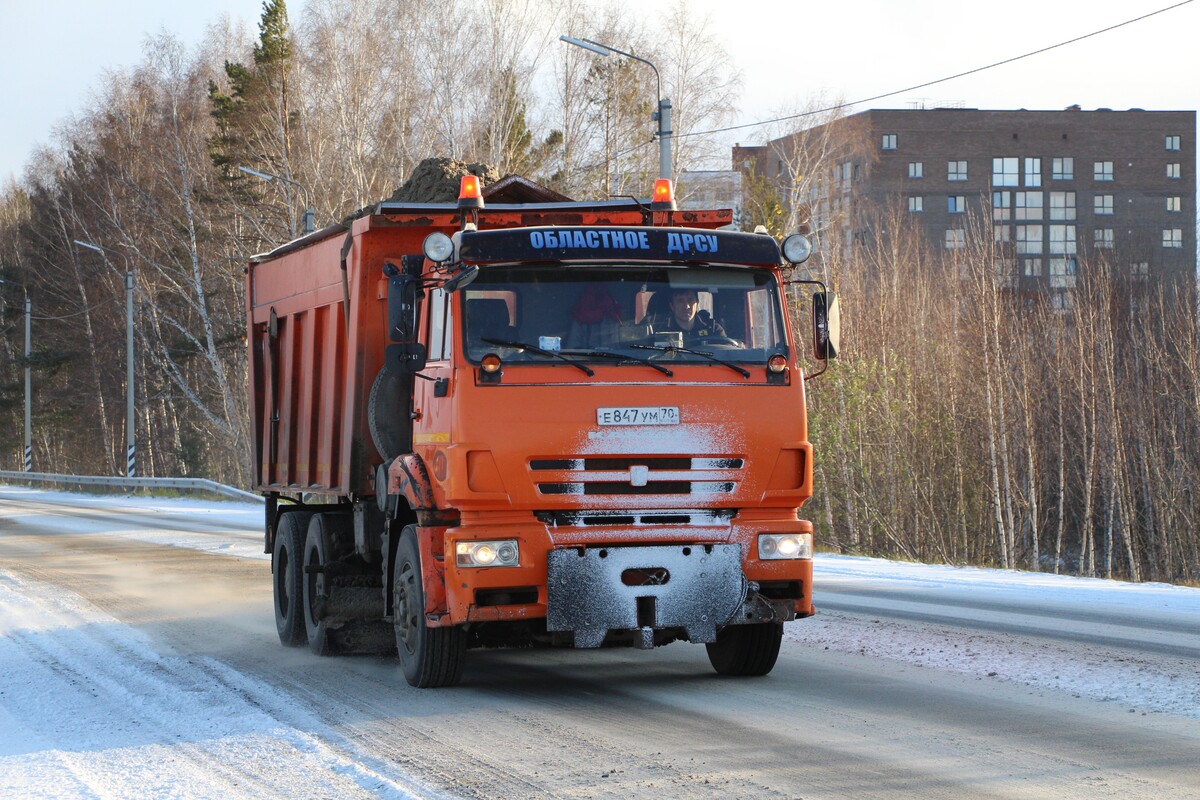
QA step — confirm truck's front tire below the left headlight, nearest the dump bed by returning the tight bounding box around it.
[392,525,467,688]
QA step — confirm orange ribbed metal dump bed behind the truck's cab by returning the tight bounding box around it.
[246,200,730,497]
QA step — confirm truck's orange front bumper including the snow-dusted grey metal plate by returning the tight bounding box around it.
[439,515,812,633]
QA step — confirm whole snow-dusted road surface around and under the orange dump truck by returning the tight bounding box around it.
[0,487,1200,800]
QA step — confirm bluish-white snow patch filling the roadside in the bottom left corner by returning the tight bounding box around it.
[0,571,439,800]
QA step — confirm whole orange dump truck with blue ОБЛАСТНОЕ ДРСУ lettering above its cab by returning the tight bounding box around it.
[246,176,836,686]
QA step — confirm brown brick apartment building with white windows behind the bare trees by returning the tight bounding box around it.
[733,106,1196,302]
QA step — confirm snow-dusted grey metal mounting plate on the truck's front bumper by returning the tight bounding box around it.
[546,545,748,648]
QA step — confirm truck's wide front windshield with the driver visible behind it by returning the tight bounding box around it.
[461,264,787,363]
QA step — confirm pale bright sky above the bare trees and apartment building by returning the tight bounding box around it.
[0,0,1200,184]
